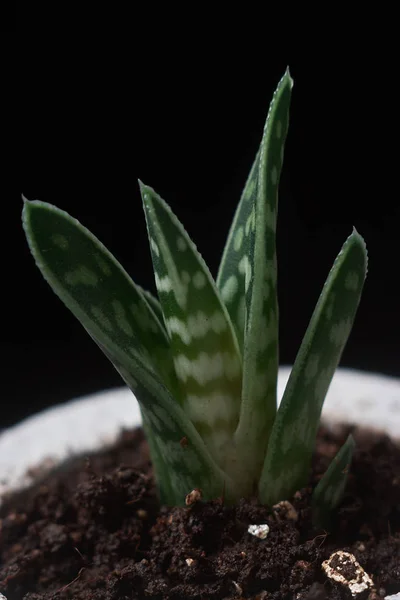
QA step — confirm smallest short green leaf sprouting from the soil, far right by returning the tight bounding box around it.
[312,435,355,527]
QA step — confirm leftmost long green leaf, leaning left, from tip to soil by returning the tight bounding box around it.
[23,201,232,504]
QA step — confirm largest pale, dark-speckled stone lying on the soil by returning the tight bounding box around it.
[322,550,374,596]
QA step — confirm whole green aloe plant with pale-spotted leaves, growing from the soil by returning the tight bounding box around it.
[23,71,367,514]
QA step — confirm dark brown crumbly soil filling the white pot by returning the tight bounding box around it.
[0,429,400,600]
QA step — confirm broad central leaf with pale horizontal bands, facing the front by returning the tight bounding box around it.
[140,183,242,488]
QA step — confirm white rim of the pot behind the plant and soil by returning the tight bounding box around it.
[0,366,400,504]
